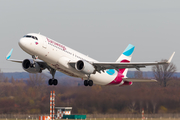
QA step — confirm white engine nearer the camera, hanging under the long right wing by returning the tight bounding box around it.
[75,60,95,74]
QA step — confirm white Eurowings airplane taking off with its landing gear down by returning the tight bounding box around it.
[6,33,175,86]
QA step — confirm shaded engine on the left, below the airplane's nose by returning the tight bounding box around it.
[22,59,42,73]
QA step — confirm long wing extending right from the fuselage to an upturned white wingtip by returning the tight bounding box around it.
[92,52,175,72]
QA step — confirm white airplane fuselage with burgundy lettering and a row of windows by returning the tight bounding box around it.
[19,33,123,85]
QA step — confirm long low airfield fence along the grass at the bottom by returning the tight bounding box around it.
[0,113,180,120]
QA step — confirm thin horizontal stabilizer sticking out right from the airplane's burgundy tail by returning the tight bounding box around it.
[123,78,157,82]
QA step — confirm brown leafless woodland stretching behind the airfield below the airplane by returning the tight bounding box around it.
[0,59,180,114]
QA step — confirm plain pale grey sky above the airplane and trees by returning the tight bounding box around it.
[0,0,180,72]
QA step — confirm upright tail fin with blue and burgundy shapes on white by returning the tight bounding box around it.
[116,44,135,78]
